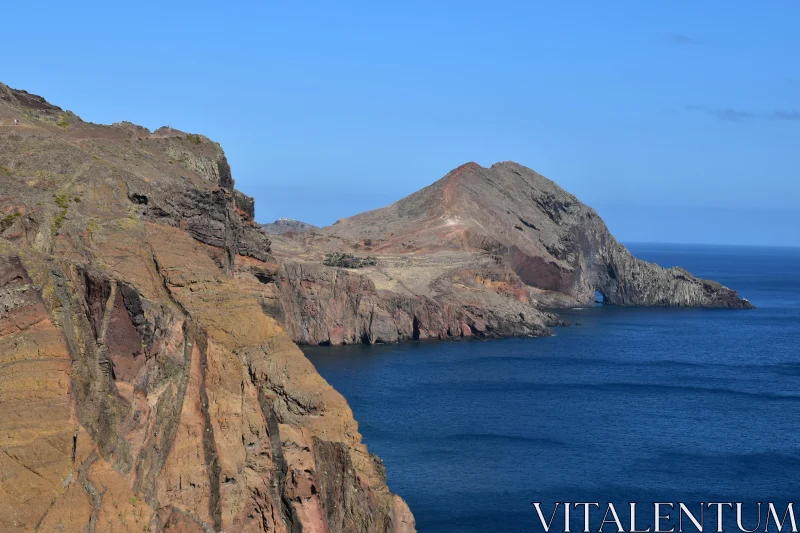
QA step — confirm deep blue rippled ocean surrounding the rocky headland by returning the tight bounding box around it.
[305,244,800,533]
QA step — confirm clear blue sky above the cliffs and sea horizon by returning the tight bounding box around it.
[0,0,800,245]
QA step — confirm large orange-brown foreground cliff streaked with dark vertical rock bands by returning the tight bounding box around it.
[0,85,414,533]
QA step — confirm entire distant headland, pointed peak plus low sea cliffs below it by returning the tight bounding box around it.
[273,162,752,344]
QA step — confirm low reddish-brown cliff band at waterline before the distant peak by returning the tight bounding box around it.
[266,261,559,344]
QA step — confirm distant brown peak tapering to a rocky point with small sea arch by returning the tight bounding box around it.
[324,162,748,308]
